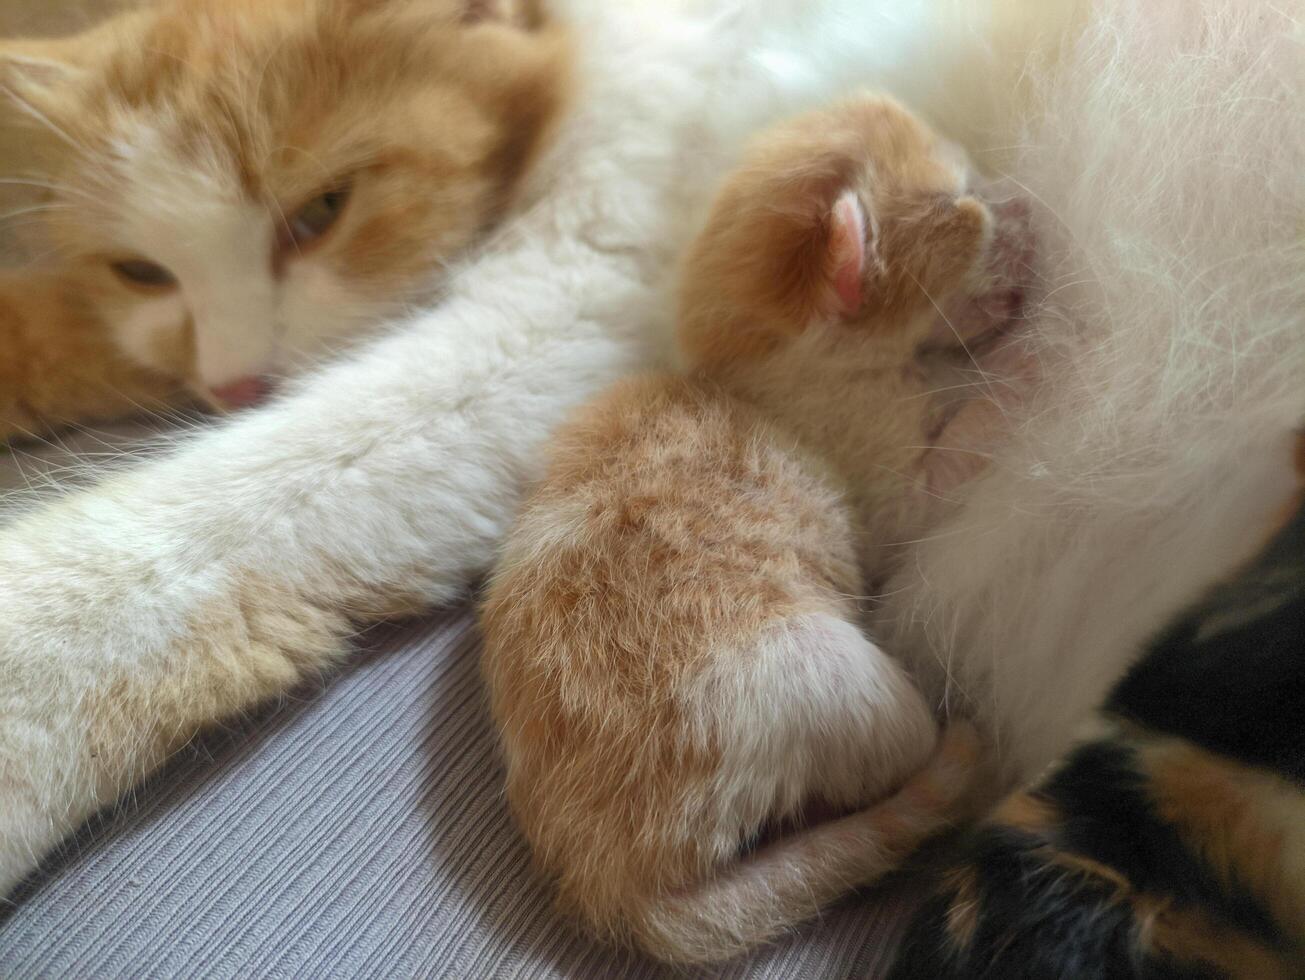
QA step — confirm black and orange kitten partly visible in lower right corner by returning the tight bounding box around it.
[894,438,1305,980]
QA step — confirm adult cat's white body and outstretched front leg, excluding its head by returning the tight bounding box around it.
[0,0,1305,918]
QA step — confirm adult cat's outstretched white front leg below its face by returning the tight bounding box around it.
[0,264,647,896]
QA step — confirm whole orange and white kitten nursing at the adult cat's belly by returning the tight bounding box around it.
[484,97,1028,962]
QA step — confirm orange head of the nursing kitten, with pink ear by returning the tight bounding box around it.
[681,97,993,360]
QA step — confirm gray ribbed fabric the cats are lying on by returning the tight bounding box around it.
[0,611,918,980]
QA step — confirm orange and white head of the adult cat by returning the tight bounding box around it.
[0,0,565,401]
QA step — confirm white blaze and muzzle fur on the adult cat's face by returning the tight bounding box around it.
[102,117,392,390]
